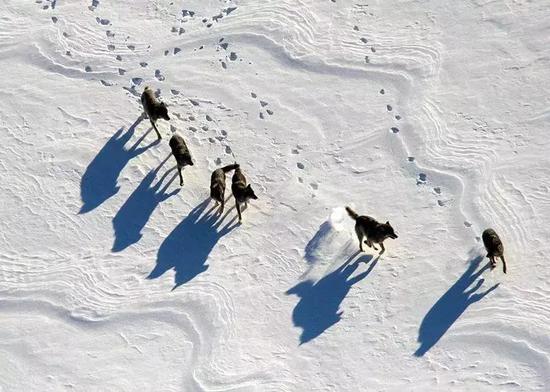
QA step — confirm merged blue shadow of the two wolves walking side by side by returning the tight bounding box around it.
[147,199,239,290]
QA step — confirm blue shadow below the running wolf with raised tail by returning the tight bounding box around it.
[286,252,378,344]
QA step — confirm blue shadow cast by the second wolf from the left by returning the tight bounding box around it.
[112,155,180,252]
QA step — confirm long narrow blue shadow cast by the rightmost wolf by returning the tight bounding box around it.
[414,256,499,357]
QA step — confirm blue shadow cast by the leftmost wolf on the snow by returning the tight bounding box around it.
[79,115,159,214]
